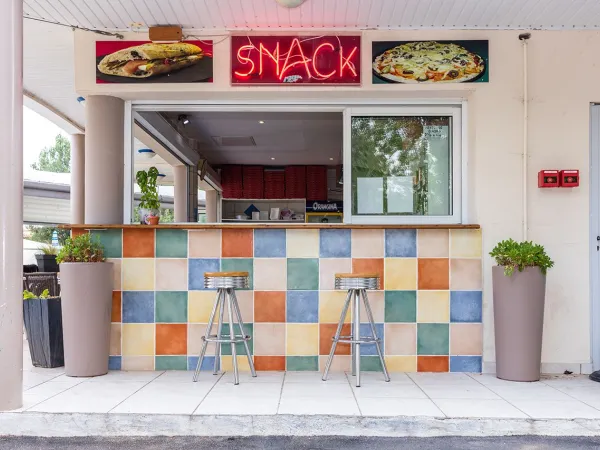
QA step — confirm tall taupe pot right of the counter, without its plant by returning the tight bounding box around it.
[492,266,546,381]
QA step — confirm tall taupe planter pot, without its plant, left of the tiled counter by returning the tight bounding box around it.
[60,262,113,377]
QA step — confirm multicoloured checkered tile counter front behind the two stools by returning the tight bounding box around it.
[92,228,482,372]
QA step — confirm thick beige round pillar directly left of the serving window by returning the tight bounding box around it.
[85,95,125,224]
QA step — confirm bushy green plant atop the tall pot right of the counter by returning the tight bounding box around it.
[490,239,554,277]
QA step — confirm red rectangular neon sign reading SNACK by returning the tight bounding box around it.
[231,36,360,84]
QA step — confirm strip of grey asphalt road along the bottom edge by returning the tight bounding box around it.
[0,436,600,450]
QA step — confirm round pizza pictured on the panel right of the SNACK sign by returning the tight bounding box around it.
[373,41,485,83]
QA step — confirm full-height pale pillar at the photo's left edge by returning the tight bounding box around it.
[0,0,23,411]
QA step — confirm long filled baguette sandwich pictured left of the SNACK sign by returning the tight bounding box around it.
[98,42,204,78]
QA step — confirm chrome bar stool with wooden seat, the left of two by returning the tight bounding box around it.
[194,272,256,384]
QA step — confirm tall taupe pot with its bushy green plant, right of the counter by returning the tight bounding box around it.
[490,239,554,381]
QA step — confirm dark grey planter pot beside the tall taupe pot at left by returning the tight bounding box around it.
[23,298,65,369]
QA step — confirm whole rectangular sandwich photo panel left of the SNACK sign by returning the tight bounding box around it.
[96,41,213,83]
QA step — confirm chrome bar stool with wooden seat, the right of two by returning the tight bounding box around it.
[323,273,390,387]
